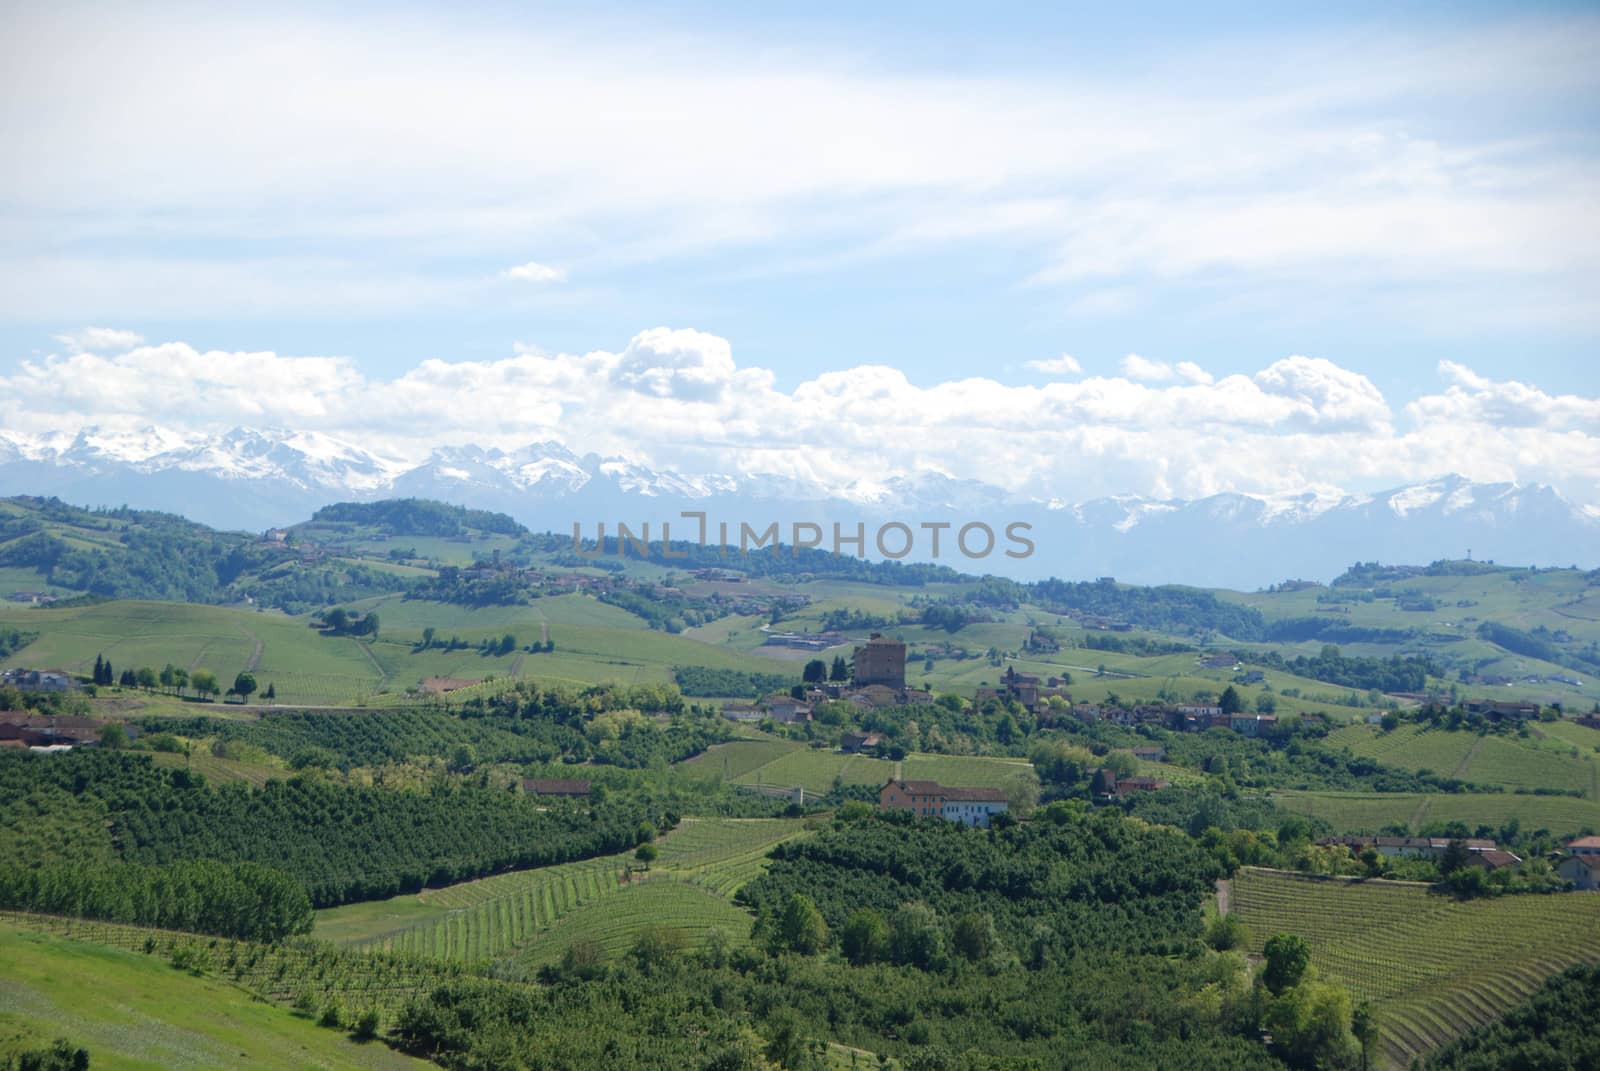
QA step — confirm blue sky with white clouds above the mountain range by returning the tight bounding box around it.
[0,3,1600,503]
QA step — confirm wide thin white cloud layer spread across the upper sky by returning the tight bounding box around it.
[0,3,1600,323]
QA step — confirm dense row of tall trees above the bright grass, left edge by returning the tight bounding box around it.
[0,860,312,941]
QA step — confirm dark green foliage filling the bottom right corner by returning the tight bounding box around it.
[1424,965,1600,1071]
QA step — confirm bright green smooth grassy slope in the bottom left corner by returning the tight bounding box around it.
[0,927,434,1071]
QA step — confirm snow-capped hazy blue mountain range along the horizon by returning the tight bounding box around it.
[0,427,1600,589]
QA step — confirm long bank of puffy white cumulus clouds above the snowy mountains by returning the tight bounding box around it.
[0,327,1600,503]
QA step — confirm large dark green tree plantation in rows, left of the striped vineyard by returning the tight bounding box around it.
[0,751,648,906]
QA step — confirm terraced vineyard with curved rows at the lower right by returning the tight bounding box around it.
[1232,868,1600,1068]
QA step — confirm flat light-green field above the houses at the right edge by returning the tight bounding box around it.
[1272,792,1600,836]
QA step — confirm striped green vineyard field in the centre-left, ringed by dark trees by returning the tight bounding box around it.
[315,818,805,964]
